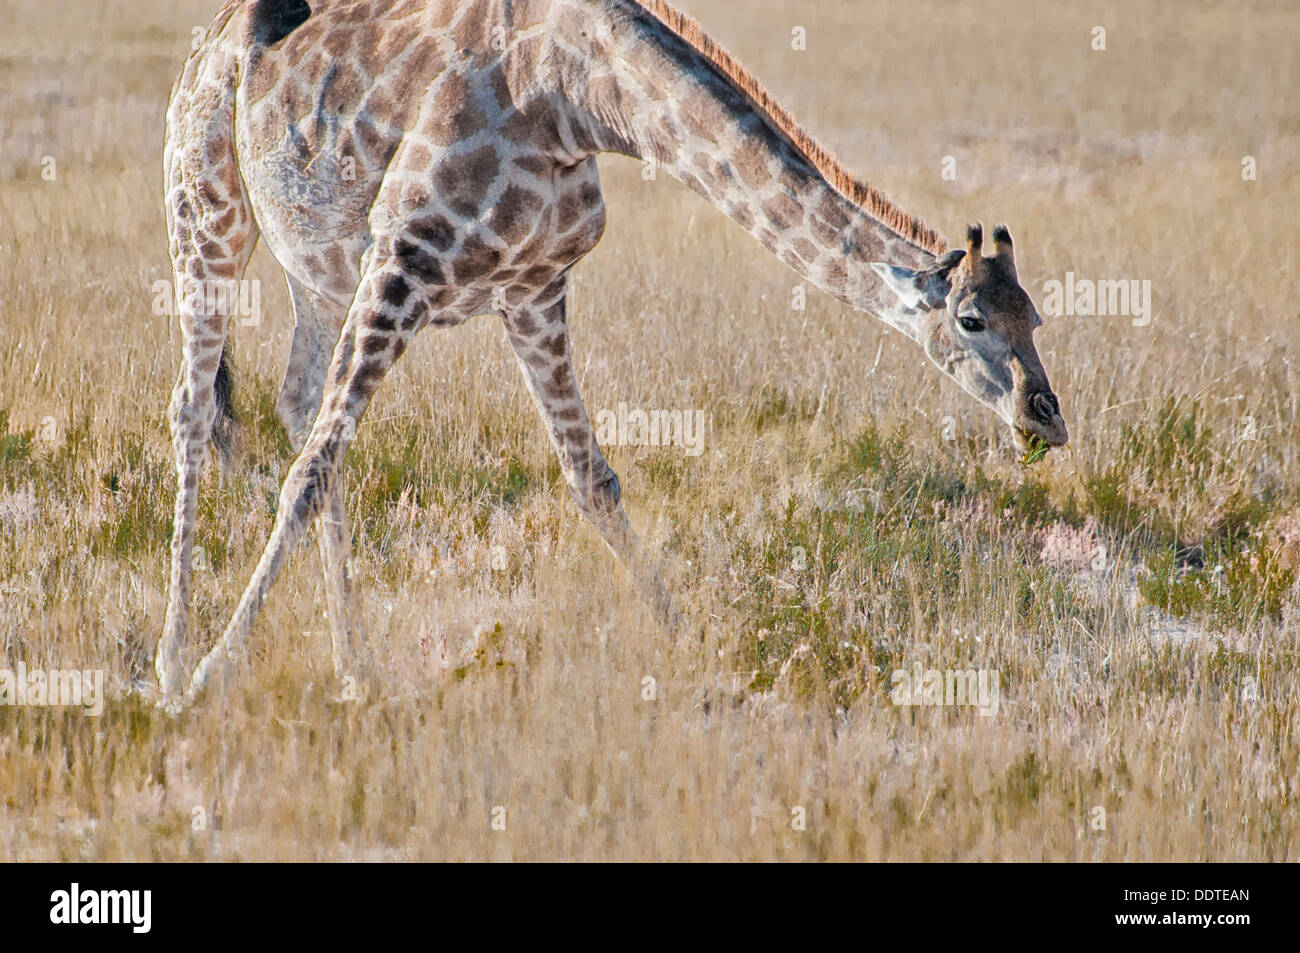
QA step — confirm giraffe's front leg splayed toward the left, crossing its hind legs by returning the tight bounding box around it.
[186,256,428,702]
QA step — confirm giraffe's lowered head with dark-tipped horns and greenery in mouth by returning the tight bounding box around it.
[871,225,1070,450]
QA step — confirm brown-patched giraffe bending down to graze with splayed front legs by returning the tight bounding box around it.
[155,0,1067,705]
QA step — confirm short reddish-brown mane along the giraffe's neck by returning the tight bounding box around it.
[632,0,948,256]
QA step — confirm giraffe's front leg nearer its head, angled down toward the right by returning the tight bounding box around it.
[504,280,677,627]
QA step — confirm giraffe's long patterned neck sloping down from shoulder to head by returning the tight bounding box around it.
[556,0,944,323]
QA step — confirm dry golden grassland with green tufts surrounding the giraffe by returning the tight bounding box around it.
[0,0,1300,861]
